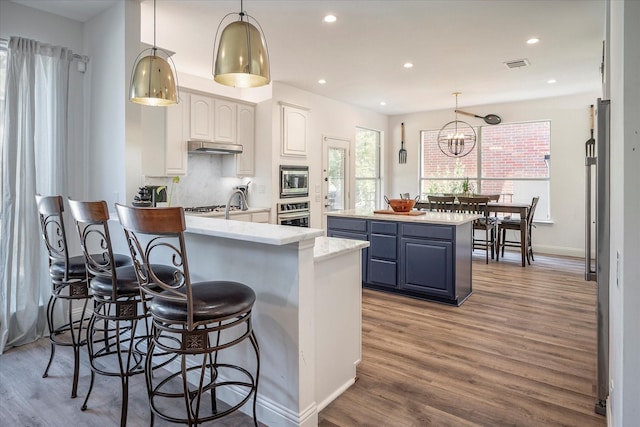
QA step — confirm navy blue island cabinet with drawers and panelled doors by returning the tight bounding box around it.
[327,213,472,305]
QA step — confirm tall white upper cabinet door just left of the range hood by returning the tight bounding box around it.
[164,94,189,176]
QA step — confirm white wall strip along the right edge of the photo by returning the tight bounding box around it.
[609,0,640,427]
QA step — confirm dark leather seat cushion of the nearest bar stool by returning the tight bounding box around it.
[149,281,256,322]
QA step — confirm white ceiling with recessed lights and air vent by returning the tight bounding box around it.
[14,0,605,115]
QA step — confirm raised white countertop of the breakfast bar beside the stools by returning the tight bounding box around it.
[185,216,324,246]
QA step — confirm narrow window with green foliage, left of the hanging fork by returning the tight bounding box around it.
[355,128,380,210]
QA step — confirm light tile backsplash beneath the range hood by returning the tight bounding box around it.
[143,154,250,207]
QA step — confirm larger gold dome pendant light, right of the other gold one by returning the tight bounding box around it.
[213,0,271,88]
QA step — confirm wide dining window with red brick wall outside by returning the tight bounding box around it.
[420,121,551,220]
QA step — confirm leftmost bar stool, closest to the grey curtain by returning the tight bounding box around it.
[35,194,131,398]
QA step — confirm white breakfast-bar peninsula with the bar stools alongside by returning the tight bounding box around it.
[112,215,368,427]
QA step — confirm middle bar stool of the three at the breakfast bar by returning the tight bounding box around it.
[69,200,179,426]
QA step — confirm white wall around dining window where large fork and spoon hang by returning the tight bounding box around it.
[386,92,601,256]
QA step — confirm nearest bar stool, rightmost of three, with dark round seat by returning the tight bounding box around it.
[116,204,260,426]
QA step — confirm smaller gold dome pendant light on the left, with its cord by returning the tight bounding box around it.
[129,0,178,107]
